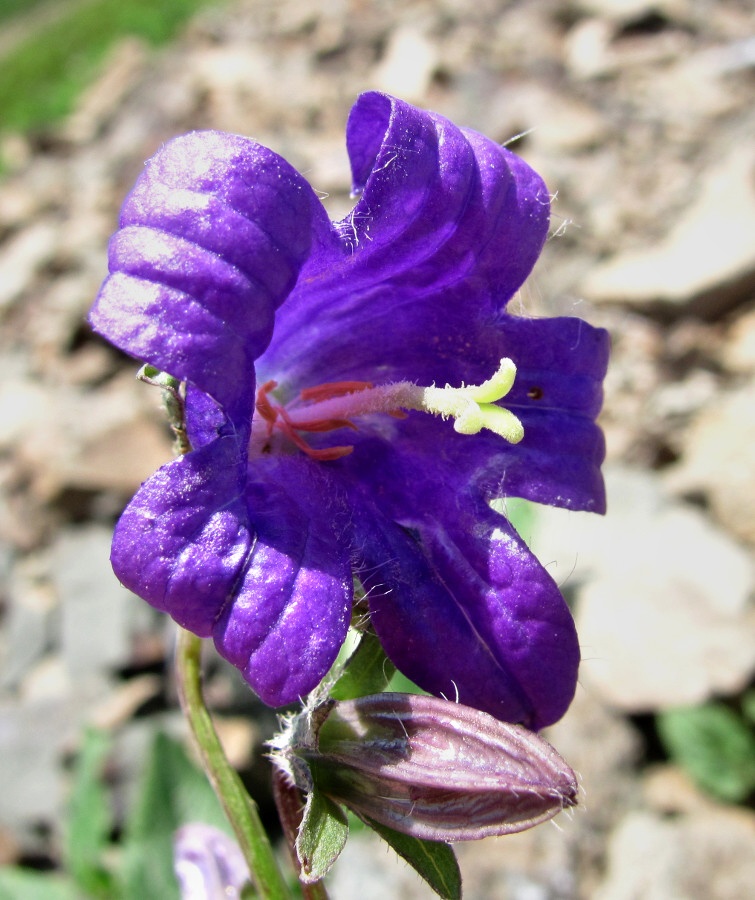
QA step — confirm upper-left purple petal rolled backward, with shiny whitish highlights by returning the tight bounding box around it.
[90,132,324,424]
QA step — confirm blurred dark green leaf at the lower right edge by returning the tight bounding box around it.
[658,703,755,803]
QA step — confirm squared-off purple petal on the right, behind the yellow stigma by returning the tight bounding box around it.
[334,316,609,521]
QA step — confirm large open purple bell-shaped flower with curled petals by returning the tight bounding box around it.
[91,93,608,728]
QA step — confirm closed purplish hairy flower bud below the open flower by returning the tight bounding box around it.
[299,693,578,841]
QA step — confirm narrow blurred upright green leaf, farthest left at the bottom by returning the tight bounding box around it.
[63,728,116,900]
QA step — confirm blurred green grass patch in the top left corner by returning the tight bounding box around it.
[0,0,220,132]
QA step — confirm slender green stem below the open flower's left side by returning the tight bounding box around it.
[176,628,291,900]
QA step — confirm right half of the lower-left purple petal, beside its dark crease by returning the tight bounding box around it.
[213,457,354,706]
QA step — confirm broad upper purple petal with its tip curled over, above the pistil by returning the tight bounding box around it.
[260,94,549,392]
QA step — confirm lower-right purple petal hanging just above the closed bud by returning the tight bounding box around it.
[360,497,579,729]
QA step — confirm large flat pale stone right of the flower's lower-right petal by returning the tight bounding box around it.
[576,510,755,712]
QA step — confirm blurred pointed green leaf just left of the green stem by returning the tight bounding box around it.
[123,734,229,900]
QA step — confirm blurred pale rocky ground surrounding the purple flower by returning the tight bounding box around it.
[0,0,755,900]
